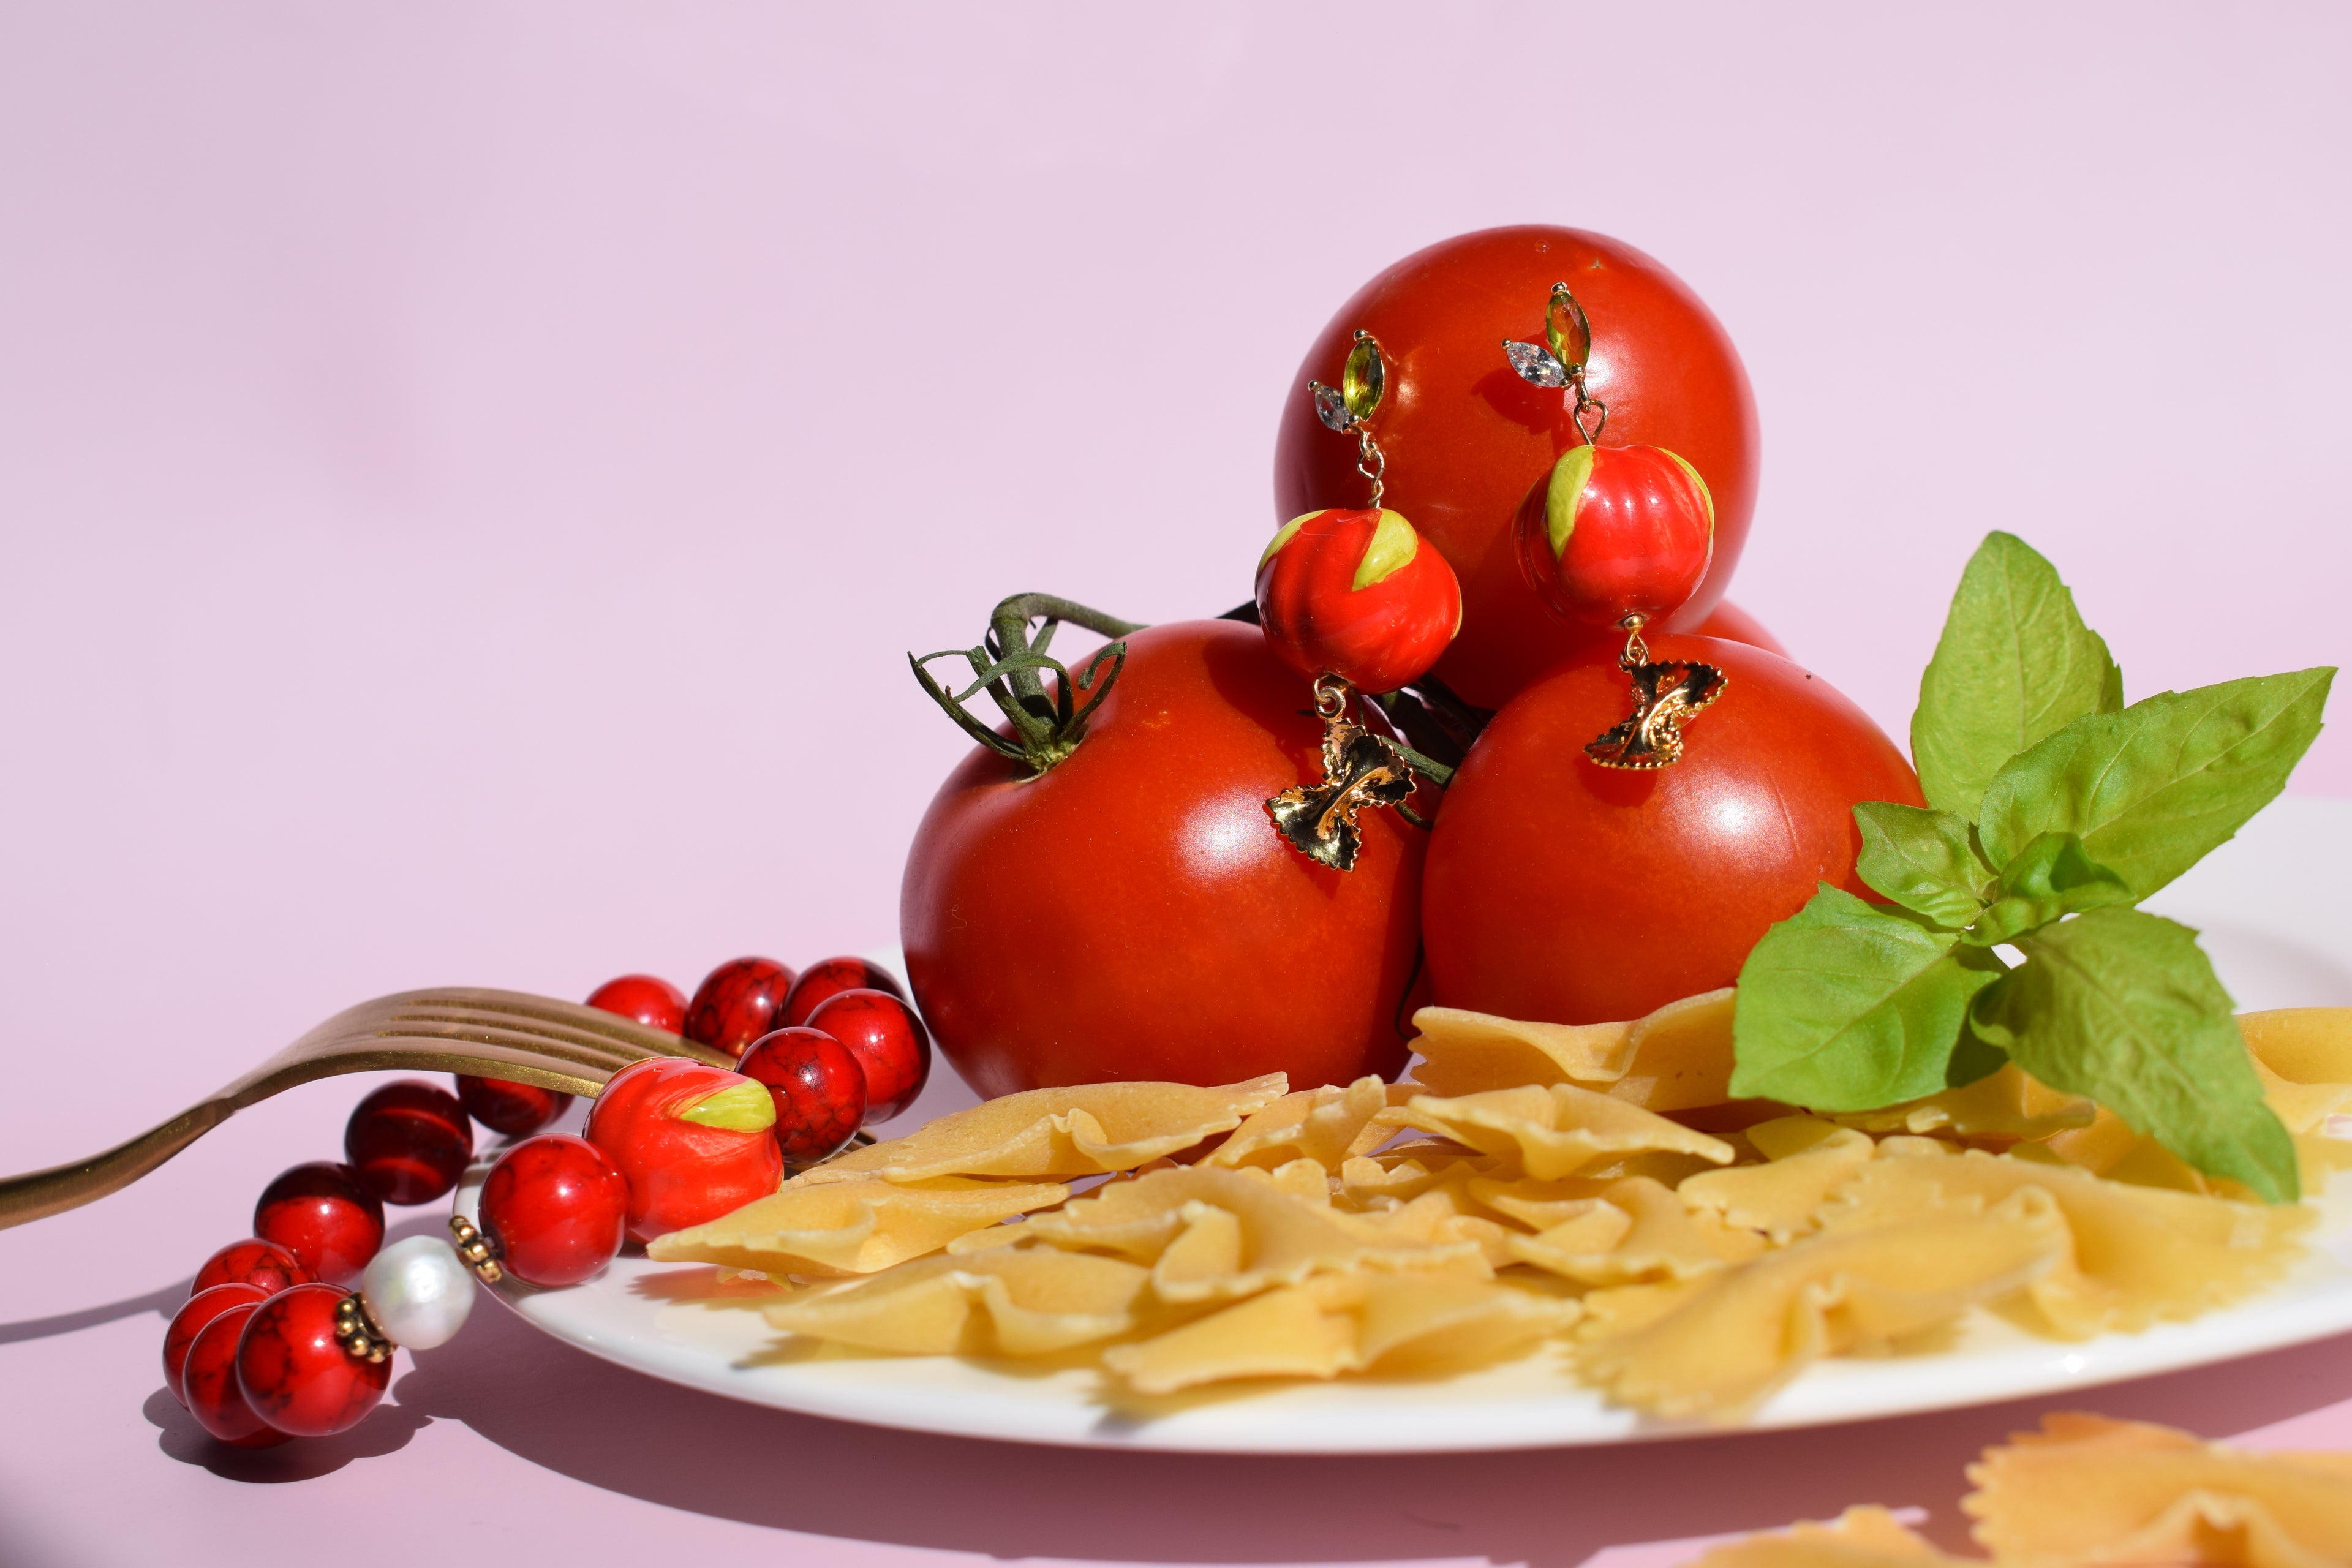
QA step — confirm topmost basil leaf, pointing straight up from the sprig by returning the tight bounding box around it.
[1912,533,2124,816]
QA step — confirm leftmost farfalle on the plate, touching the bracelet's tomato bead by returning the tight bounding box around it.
[644,1178,1070,1276]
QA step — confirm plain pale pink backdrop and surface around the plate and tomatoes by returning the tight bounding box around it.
[0,0,2352,1568]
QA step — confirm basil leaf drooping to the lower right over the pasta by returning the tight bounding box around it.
[1973,910,2301,1204]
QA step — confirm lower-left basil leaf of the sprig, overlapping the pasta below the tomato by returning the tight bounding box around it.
[1731,881,2002,1110]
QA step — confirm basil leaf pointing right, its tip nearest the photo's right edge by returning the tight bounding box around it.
[1976,668,2335,898]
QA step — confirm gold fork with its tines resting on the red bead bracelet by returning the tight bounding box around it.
[0,985,734,1229]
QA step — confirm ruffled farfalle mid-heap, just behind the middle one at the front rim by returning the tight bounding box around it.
[1023,1166,1487,1302]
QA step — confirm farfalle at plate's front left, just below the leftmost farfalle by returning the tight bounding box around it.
[767,1246,1150,1357]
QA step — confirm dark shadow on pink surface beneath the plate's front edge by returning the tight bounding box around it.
[133,1302,2352,1568]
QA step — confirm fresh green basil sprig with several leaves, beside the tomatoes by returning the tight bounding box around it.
[1731,533,2335,1204]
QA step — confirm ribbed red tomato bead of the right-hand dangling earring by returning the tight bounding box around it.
[1517,447,1714,628]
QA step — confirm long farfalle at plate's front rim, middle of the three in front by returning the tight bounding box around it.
[1103,1272,1578,1394]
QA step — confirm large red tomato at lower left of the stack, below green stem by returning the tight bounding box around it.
[899,620,1425,1096]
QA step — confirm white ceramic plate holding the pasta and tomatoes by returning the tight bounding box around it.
[456,799,2352,1453]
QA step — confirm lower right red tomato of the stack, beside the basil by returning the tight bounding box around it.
[1420,637,1924,1023]
